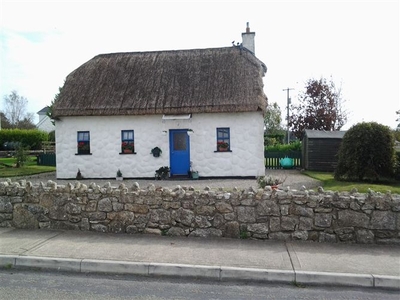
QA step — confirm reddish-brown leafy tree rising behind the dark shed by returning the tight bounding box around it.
[289,78,347,139]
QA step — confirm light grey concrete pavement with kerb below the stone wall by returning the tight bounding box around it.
[0,228,400,290]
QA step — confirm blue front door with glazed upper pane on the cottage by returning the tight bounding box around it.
[169,129,190,176]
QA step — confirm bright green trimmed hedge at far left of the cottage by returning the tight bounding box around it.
[0,129,49,150]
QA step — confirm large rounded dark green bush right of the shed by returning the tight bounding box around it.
[335,122,395,182]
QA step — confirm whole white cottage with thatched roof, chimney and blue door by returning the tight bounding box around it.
[53,27,267,179]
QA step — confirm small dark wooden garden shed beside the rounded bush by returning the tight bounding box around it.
[302,129,346,172]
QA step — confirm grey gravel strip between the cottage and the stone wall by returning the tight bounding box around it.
[8,169,320,190]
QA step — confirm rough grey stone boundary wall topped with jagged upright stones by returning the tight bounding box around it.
[0,180,400,244]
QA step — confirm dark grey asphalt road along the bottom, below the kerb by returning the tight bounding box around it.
[0,270,399,300]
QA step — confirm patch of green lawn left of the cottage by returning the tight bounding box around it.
[0,156,56,178]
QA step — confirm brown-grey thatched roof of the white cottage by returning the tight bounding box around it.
[53,47,267,118]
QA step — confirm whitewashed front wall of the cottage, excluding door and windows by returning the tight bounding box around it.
[56,112,265,179]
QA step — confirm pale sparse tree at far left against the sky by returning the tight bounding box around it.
[4,90,34,128]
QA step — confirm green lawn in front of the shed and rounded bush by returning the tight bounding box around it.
[303,171,400,194]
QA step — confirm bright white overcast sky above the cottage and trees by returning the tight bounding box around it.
[0,0,400,130]
